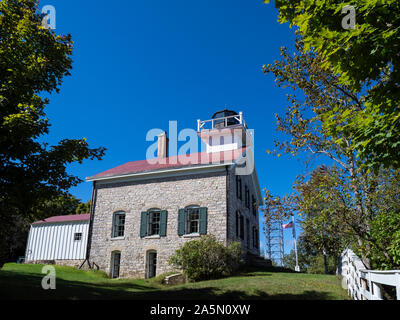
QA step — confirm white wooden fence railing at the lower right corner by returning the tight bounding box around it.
[337,249,400,300]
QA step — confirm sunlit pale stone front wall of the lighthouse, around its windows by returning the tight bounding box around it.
[90,170,227,278]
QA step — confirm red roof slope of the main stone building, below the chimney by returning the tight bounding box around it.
[86,148,246,180]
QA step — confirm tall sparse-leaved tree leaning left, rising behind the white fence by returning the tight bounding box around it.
[264,40,393,268]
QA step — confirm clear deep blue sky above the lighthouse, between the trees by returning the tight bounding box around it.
[41,0,305,255]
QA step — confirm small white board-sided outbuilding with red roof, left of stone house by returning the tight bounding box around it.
[25,214,90,263]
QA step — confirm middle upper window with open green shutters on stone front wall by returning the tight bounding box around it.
[140,208,168,238]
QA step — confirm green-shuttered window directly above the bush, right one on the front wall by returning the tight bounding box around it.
[178,206,207,236]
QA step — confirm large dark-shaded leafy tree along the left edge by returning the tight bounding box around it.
[0,0,105,266]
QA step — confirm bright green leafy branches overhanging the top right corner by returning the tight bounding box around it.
[264,0,400,167]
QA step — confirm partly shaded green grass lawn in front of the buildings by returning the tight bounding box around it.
[0,263,348,300]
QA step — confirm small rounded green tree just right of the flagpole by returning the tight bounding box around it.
[295,166,352,272]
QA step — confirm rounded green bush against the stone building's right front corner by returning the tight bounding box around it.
[169,235,243,281]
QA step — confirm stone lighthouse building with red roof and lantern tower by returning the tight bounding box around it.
[86,110,262,278]
